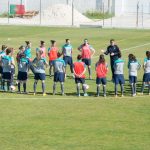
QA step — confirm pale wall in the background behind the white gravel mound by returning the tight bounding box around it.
[0,0,101,13]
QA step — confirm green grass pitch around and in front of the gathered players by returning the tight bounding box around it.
[0,26,150,150]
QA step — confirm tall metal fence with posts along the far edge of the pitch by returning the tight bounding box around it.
[0,0,150,28]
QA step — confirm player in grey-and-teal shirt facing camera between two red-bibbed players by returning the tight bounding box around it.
[62,39,74,77]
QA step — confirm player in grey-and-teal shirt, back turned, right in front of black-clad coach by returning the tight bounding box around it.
[114,53,125,97]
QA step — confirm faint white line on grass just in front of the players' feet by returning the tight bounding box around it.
[0,95,150,101]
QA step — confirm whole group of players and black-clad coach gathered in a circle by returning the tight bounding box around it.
[0,39,150,97]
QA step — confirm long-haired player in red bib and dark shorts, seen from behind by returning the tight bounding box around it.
[95,55,108,97]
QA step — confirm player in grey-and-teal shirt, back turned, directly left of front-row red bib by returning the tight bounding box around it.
[53,52,65,95]
